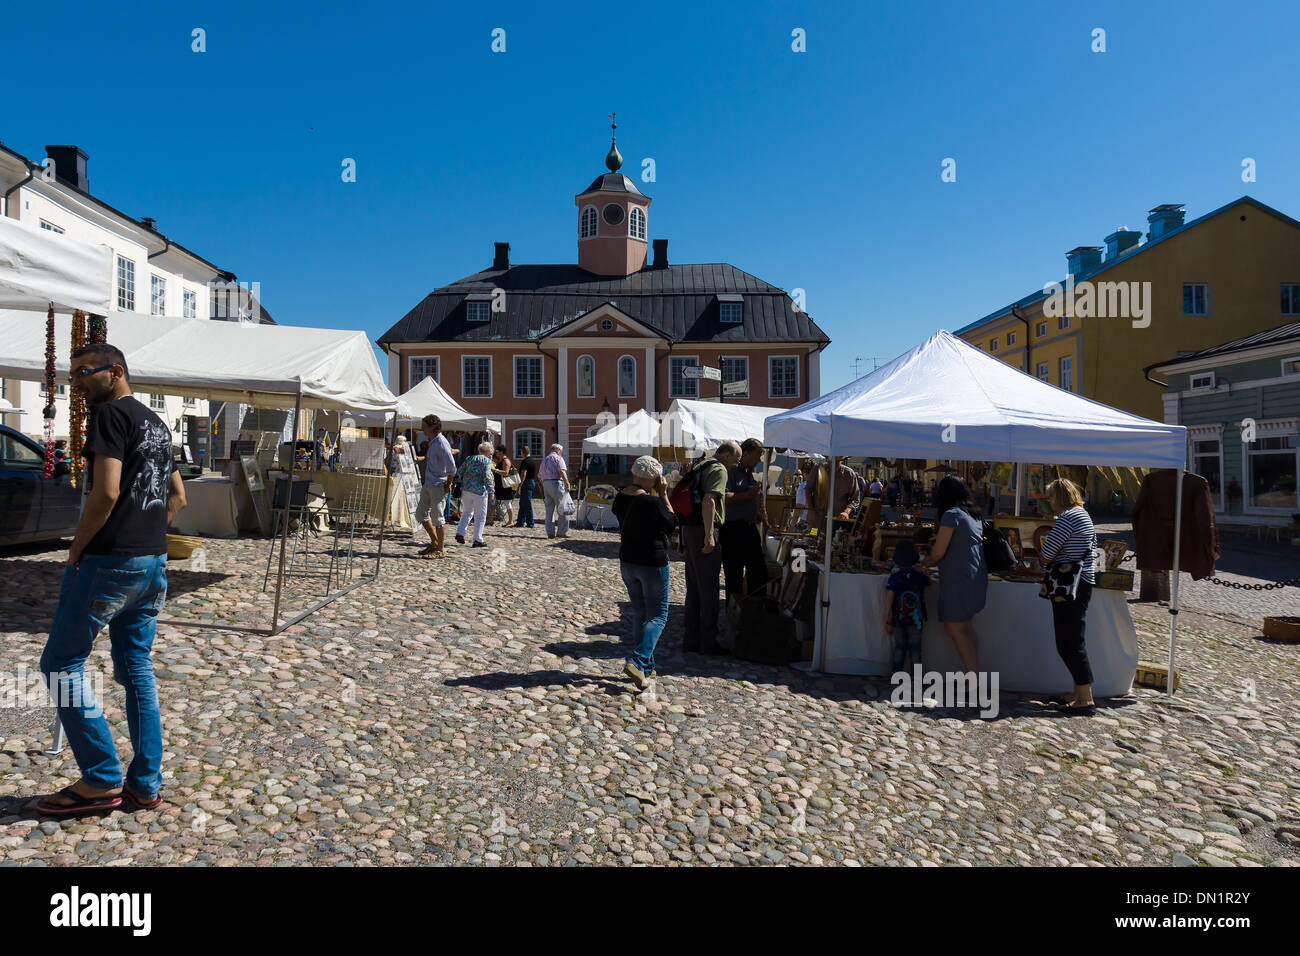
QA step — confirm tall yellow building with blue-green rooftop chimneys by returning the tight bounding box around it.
[957,196,1300,421]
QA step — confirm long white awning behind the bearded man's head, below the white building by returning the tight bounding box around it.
[0,311,397,412]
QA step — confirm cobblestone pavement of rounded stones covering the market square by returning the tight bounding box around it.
[0,528,1300,866]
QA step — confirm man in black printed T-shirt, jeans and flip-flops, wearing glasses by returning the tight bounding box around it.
[36,343,185,817]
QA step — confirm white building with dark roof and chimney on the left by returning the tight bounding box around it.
[0,144,272,466]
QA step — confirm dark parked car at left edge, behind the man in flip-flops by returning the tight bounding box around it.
[0,425,81,545]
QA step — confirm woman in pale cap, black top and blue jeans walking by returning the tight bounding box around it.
[614,455,677,689]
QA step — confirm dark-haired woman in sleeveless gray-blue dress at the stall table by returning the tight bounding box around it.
[927,475,988,674]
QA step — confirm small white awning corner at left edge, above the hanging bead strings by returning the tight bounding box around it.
[0,216,113,312]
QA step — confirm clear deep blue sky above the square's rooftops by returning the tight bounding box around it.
[0,0,1300,390]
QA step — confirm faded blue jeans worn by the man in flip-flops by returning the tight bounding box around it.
[40,554,166,800]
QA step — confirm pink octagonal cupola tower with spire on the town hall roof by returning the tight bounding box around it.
[577,113,650,276]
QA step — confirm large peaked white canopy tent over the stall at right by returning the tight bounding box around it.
[764,332,1187,693]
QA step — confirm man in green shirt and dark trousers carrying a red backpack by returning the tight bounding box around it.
[681,441,740,654]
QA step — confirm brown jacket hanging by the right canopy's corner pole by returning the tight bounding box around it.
[1134,468,1219,580]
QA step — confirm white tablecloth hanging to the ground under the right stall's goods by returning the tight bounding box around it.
[818,574,1138,697]
